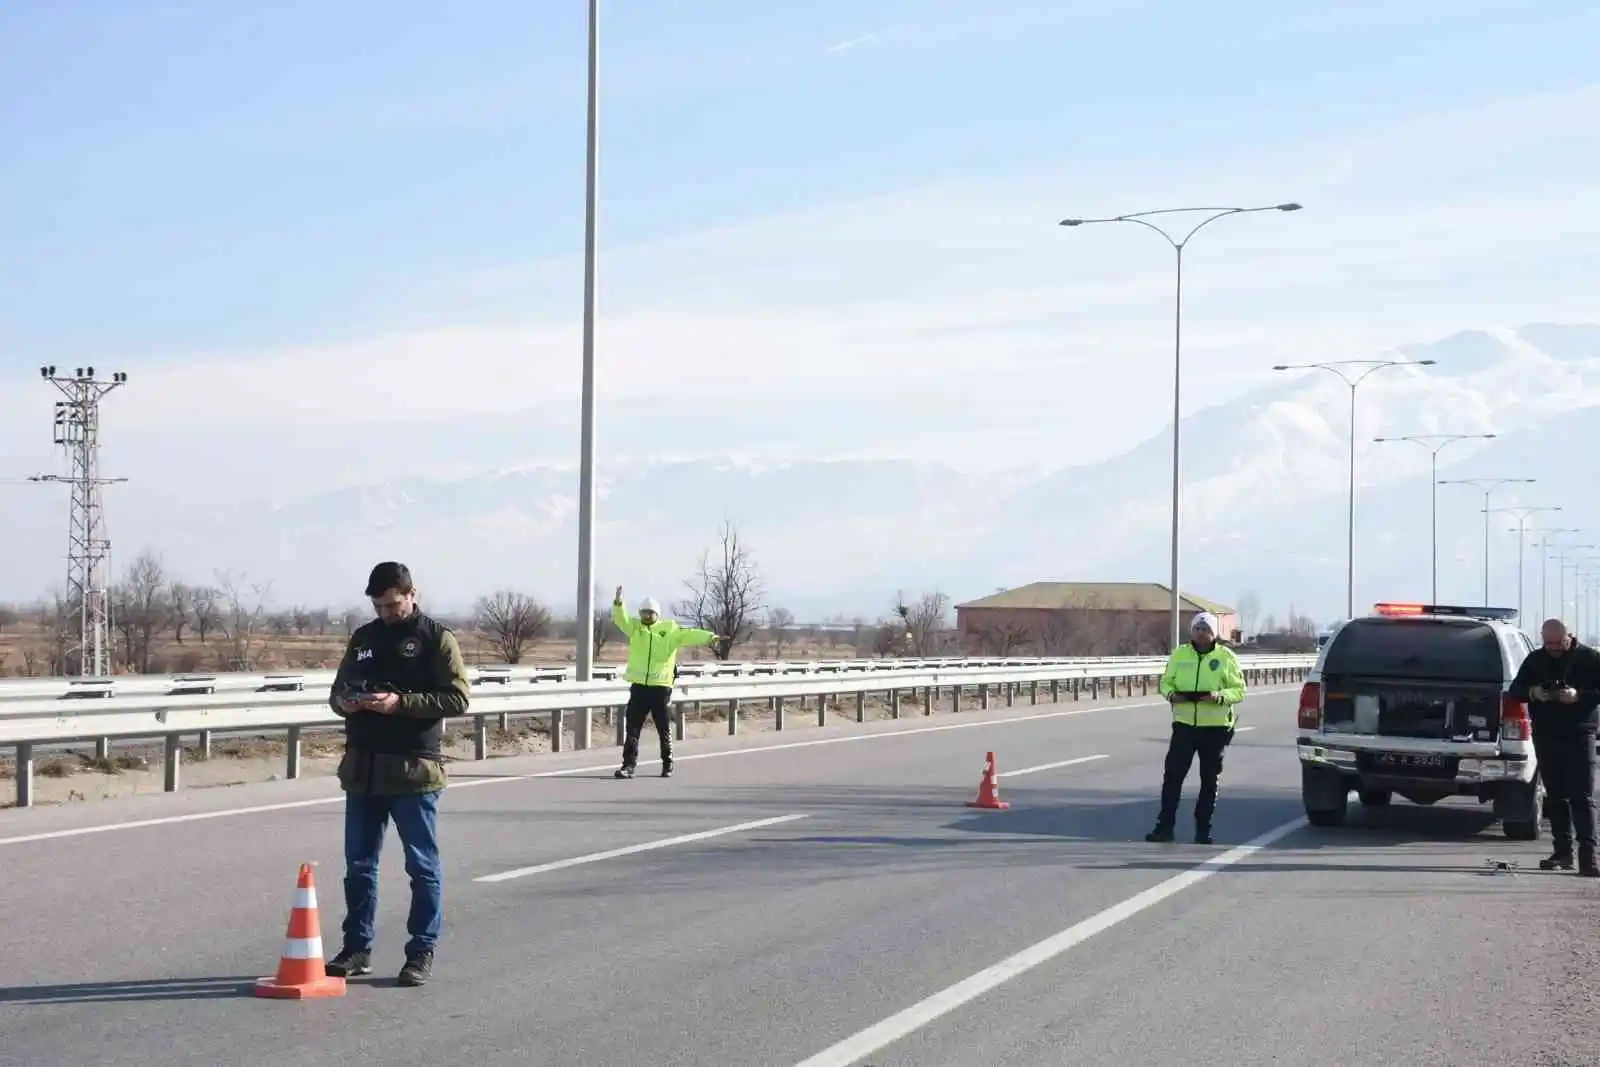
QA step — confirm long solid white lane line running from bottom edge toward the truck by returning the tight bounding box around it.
[797,817,1306,1067]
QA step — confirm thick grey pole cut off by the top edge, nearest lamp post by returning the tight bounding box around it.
[576,0,600,681]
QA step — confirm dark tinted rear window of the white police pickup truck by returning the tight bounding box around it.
[1322,619,1504,681]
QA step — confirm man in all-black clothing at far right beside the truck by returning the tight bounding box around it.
[1510,619,1600,878]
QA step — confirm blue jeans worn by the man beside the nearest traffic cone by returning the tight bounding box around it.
[344,790,445,957]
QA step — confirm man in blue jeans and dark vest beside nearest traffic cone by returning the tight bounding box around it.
[326,563,472,985]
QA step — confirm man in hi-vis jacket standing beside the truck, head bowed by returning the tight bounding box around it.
[1144,611,1245,845]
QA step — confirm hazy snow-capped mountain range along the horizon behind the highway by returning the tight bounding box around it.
[6,325,1600,621]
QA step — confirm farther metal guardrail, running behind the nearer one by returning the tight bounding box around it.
[0,656,1203,707]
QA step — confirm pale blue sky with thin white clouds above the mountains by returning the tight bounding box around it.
[0,0,1600,601]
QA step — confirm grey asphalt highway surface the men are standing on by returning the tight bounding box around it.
[0,691,1600,1067]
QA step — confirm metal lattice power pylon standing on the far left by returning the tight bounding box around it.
[29,366,128,677]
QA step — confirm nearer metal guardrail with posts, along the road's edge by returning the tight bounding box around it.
[0,656,1315,808]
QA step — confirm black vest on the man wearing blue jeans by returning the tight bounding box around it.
[344,611,450,758]
